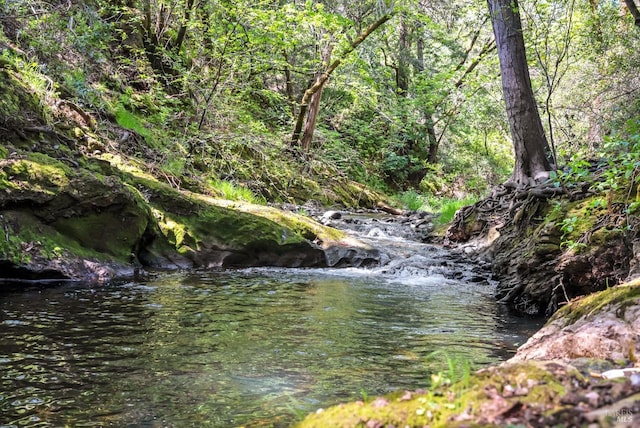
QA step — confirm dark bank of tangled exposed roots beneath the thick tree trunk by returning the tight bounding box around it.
[444,175,640,315]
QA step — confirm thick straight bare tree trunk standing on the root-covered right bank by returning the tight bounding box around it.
[487,0,551,187]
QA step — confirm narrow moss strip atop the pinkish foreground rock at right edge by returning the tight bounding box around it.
[549,280,640,326]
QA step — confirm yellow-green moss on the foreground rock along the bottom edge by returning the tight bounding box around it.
[298,362,568,428]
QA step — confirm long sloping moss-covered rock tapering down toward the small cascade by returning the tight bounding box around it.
[129,175,378,267]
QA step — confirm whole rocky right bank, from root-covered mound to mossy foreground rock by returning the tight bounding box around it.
[300,189,640,428]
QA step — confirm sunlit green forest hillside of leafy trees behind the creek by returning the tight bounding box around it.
[0,0,640,209]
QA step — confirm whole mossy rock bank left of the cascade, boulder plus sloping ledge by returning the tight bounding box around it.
[0,152,378,279]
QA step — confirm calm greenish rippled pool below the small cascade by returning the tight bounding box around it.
[0,269,538,427]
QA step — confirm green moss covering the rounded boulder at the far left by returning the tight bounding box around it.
[0,153,150,263]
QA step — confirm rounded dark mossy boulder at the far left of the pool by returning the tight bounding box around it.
[0,153,150,280]
